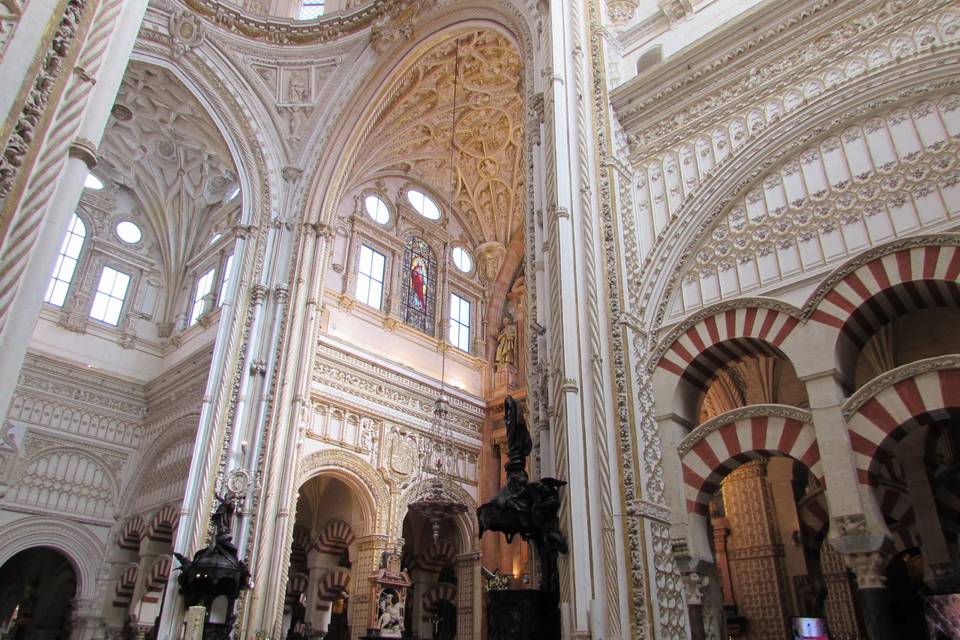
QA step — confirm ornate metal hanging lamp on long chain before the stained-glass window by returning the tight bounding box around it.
[408,38,467,542]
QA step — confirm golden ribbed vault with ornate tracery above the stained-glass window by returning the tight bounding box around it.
[354,30,524,246]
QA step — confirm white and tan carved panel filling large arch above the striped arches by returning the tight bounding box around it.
[676,94,960,310]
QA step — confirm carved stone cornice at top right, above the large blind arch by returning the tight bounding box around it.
[611,0,949,159]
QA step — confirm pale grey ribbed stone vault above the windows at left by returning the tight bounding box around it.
[98,63,239,330]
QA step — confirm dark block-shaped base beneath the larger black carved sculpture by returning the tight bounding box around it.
[485,589,560,640]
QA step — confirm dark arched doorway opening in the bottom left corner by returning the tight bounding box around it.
[0,548,77,640]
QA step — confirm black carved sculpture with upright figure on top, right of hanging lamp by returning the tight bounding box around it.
[477,396,567,593]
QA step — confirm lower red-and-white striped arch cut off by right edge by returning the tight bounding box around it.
[848,369,960,484]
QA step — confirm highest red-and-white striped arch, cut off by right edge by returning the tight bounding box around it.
[810,246,960,345]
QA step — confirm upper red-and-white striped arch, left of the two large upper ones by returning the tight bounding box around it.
[657,306,799,388]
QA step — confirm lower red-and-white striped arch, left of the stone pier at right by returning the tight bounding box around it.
[680,407,823,516]
